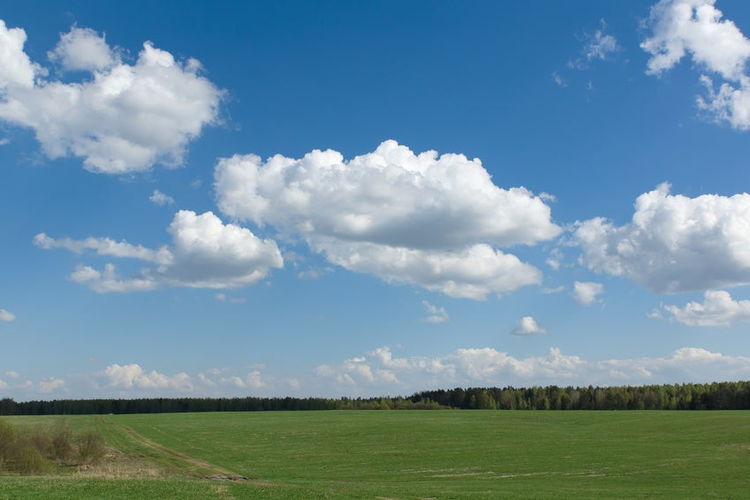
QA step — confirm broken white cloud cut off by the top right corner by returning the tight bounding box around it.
[641,0,750,130]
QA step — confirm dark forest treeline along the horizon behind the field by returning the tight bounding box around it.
[0,381,750,415]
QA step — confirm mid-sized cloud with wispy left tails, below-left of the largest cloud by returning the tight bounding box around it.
[34,210,284,292]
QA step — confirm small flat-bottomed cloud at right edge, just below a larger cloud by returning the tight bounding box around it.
[664,290,750,326]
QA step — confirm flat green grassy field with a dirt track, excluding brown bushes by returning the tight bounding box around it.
[0,411,750,499]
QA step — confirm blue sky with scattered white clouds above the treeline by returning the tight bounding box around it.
[0,0,750,401]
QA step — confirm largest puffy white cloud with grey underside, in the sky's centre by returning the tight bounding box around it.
[215,141,560,299]
